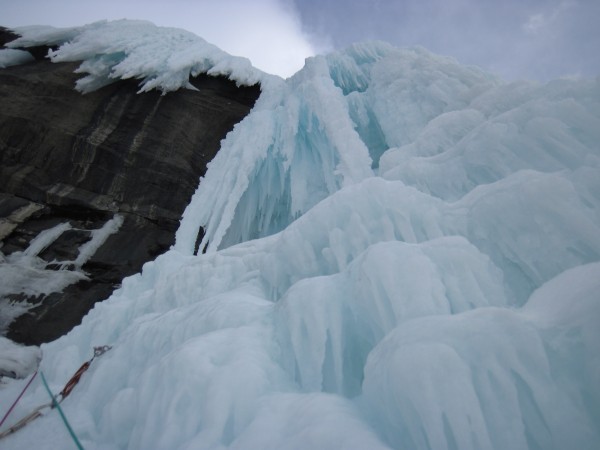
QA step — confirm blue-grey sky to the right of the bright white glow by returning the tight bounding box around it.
[295,0,600,80]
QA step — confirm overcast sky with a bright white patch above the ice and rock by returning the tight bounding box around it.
[0,0,600,80]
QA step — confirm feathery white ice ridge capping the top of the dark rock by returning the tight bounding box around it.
[7,20,276,93]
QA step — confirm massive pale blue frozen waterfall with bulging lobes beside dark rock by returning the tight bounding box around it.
[0,20,600,450]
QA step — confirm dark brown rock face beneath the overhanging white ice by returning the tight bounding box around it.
[0,30,260,344]
